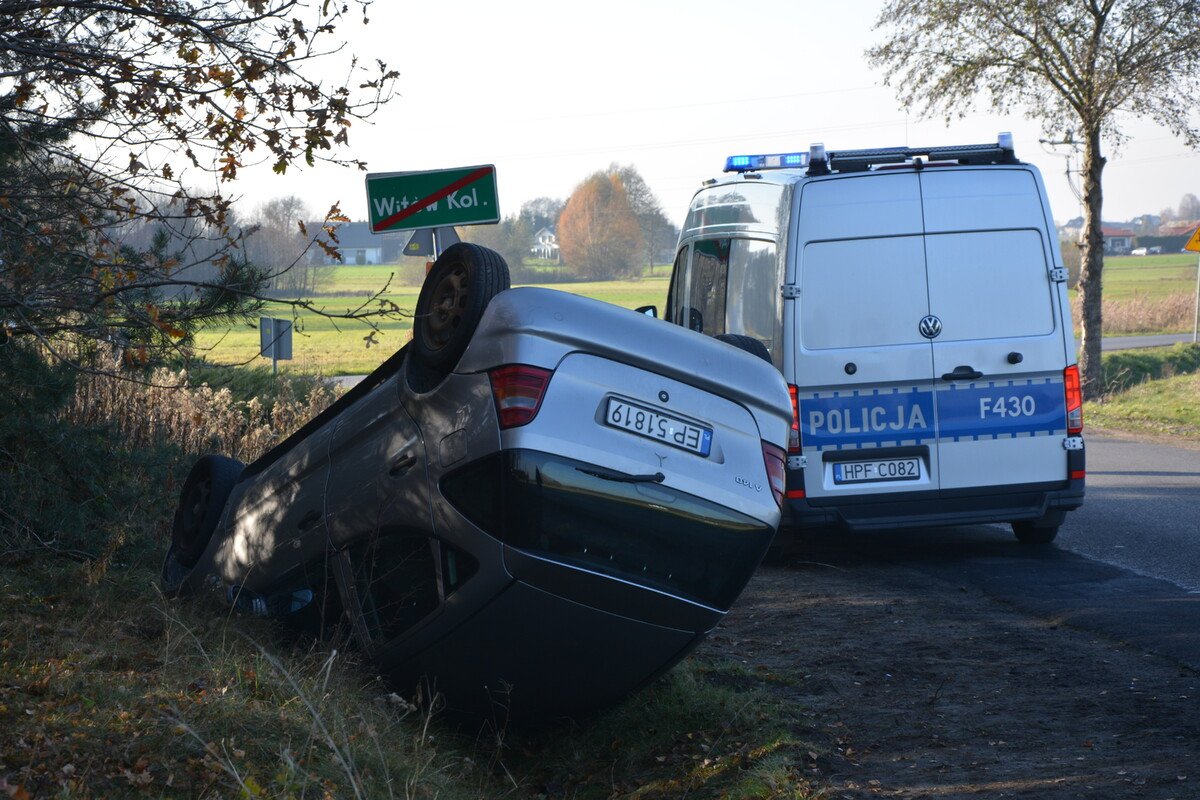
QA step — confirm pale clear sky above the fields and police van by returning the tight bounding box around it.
[235,0,1200,231]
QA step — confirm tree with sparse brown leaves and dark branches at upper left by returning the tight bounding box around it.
[0,0,395,376]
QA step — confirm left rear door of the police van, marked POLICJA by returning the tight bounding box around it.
[790,173,940,499]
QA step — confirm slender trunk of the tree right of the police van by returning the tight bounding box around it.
[1079,126,1105,399]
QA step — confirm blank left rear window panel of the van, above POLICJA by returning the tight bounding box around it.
[800,236,931,350]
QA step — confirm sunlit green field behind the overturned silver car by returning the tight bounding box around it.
[196,275,667,375]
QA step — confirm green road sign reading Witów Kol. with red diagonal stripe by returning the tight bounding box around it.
[367,164,500,234]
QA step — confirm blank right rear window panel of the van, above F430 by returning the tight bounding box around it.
[925,230,1055,342]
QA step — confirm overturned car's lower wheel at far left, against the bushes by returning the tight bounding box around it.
[164,456,246,568]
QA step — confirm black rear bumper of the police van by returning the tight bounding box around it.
[782,450,1086,530]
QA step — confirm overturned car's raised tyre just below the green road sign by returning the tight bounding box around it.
[413,242,510,373]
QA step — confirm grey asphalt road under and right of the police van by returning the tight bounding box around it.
[802,435,1200,670]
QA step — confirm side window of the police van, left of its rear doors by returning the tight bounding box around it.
[670,237,782,366]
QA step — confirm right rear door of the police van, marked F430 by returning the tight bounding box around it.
[920,168,1067,489]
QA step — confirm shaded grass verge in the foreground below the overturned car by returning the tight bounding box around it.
[0,547,820,800]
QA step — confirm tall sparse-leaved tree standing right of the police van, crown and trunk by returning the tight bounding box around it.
[866,0,1200,397]
